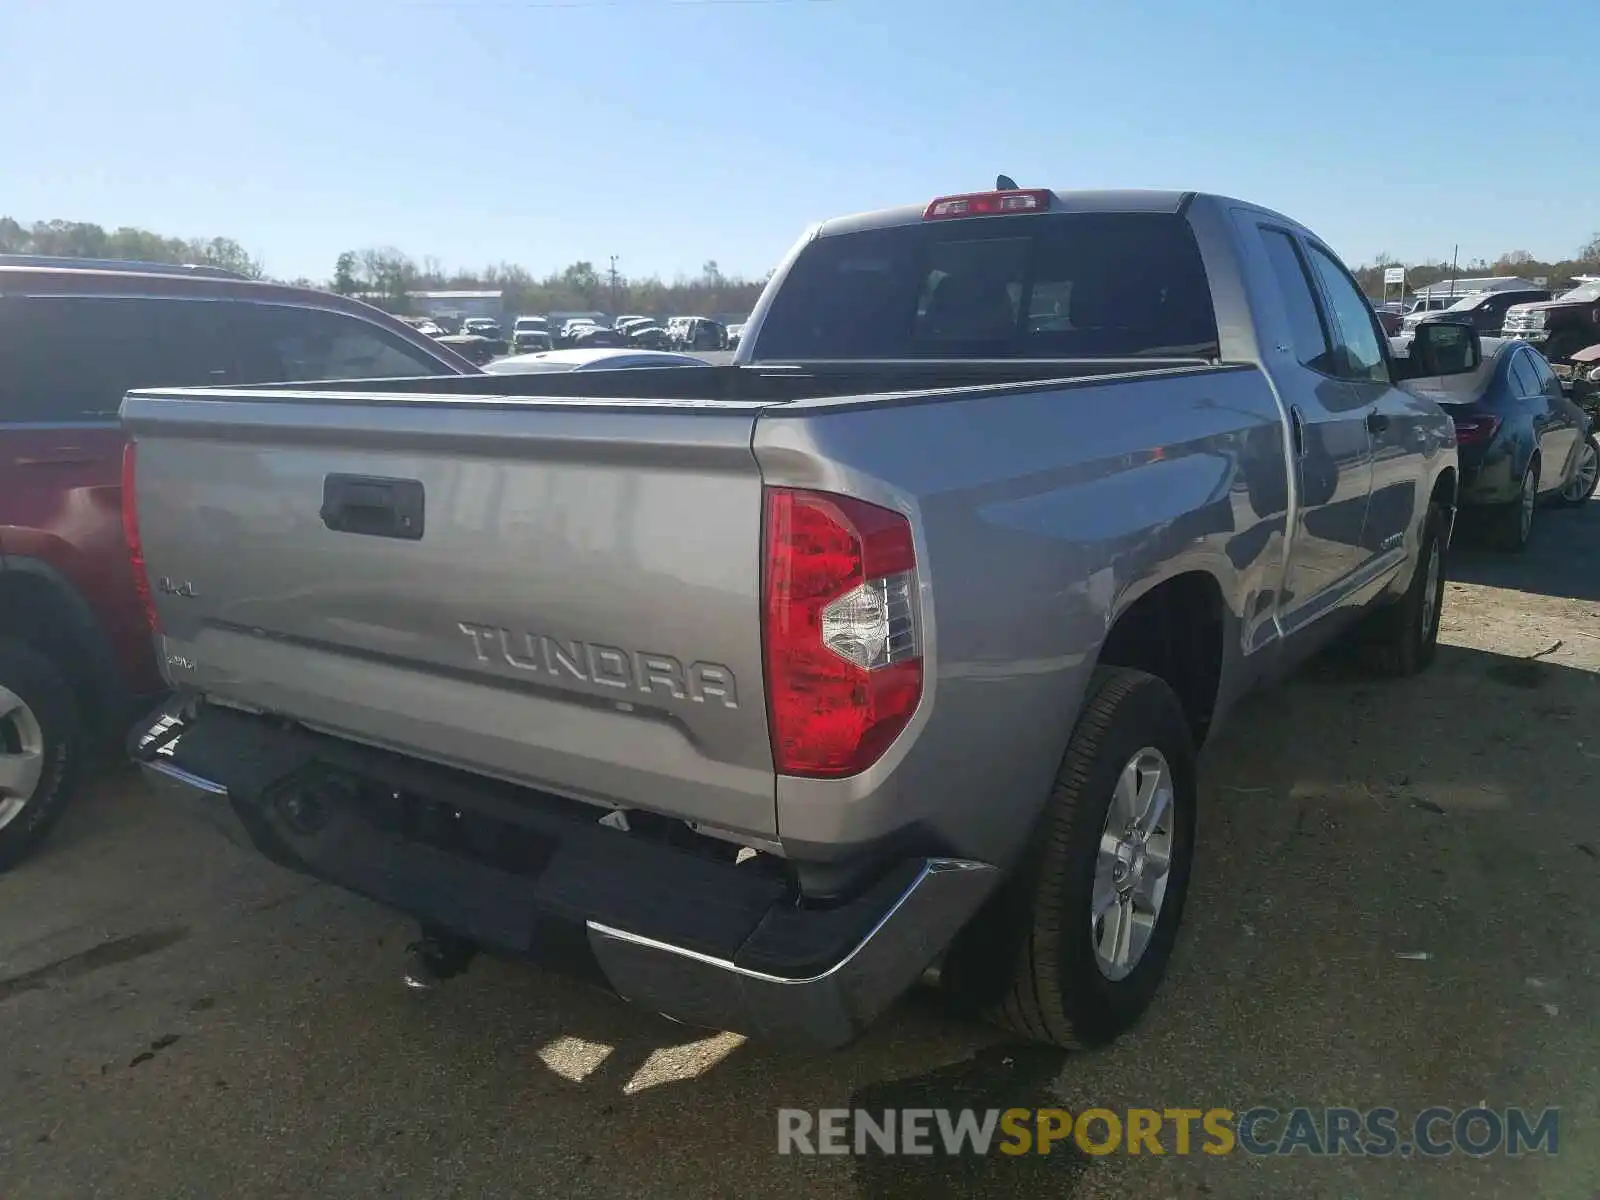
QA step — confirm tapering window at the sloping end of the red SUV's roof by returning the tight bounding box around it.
[232,304,451,384]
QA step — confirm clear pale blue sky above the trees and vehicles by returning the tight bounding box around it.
[0,0,1600,278]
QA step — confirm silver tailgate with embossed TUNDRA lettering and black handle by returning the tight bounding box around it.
[123,390,776,837]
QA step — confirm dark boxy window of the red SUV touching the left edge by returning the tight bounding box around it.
[0,296,237,422]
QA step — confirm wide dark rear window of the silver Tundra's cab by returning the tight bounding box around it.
[755,213,1218,360]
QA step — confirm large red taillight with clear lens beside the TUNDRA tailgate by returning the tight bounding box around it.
[762,488,922,778]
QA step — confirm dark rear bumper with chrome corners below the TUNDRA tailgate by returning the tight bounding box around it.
[130,699,998,1046]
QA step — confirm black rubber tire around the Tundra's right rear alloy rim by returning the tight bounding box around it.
[941,667,1195,1048]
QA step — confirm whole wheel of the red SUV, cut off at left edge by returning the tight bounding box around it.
[0,642,83,870]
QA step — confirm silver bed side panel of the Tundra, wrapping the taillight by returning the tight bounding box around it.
[755,368,1288,864]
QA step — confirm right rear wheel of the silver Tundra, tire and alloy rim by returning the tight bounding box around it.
[941,667,1195,1046]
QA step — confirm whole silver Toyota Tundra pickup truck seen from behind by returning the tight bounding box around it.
[123,189,1482,1045]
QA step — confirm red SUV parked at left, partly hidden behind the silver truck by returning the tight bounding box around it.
[0,256,472,869]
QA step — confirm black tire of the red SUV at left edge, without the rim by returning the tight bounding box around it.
[0,642,85,870]
